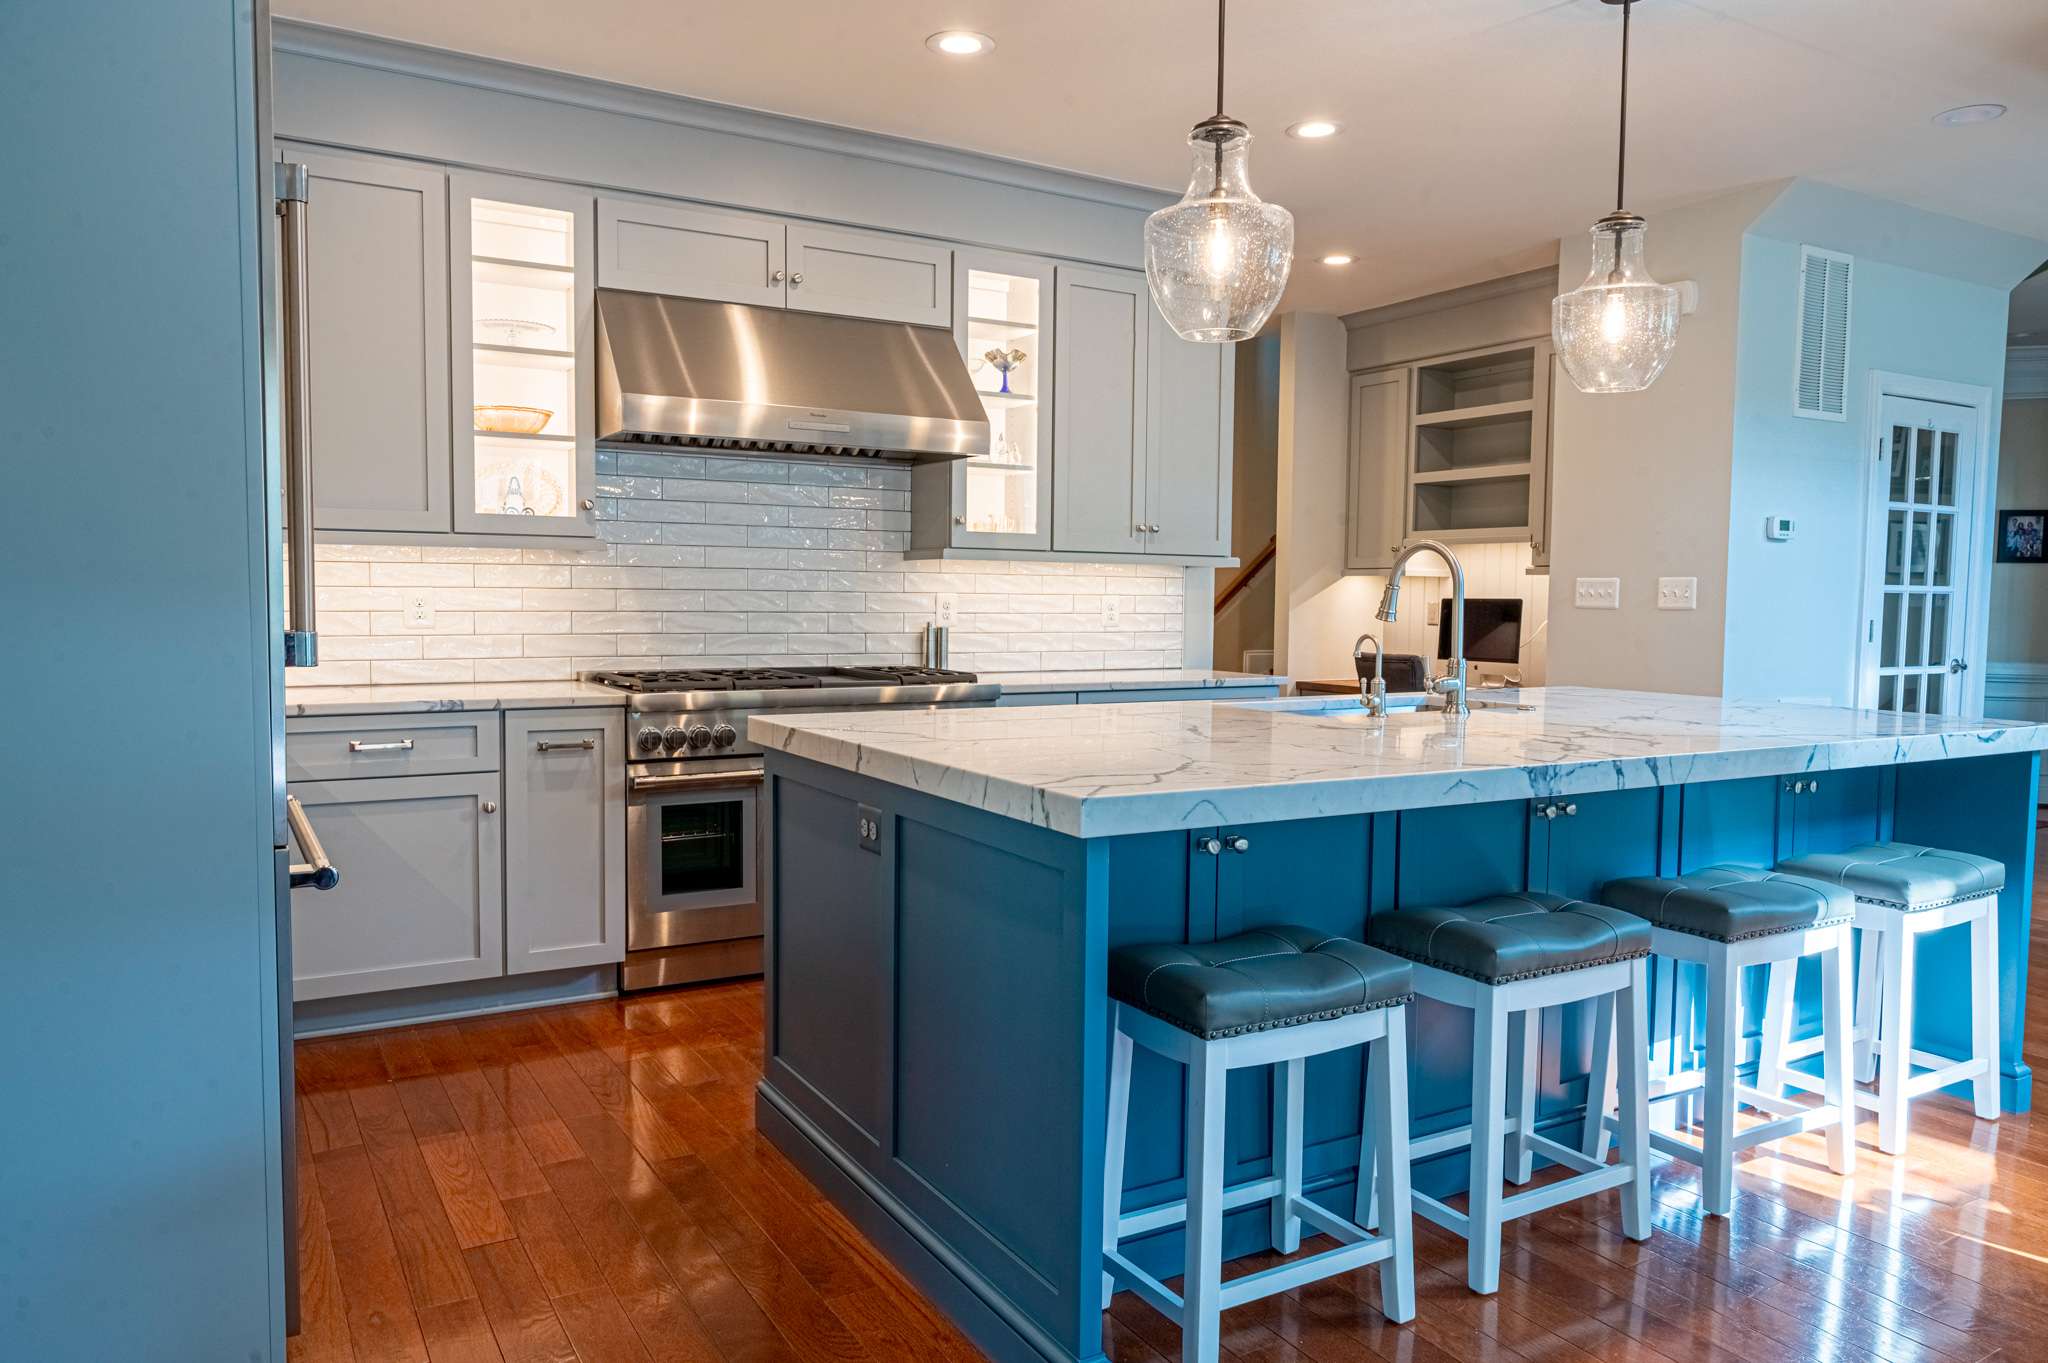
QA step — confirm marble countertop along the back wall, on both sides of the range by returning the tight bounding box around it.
[285,667,1286,718]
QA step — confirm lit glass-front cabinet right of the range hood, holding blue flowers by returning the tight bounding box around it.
[948,250,1053,548]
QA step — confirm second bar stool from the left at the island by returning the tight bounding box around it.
[1358,894,1651,1291]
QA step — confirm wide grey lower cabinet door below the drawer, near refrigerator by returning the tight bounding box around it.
[291,772,504,999]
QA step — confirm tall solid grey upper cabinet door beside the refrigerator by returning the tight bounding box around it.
[281,145,449,532]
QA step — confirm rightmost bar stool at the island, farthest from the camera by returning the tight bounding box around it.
[1757,843,2005,1154]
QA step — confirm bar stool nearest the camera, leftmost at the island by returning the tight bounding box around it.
[1102,927,1415,1363]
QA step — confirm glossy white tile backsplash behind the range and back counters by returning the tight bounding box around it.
[291,450,1184,686]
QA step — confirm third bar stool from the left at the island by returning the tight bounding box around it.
[1583,866,1855,1216]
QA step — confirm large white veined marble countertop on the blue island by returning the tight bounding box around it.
[750,688,2048,837]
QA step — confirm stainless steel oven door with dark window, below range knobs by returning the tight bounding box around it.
[627,761,762,952]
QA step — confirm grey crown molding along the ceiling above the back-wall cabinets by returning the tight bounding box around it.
[270,18,1178,213]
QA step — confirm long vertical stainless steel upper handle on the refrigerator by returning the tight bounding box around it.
[274,162,319,667]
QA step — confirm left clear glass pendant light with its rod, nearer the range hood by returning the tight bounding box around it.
[1145,0,1294,342]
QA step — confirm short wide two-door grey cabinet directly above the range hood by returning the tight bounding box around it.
[598,199,952,327]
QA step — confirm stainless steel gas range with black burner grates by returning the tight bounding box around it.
[586,667,1001,988]
